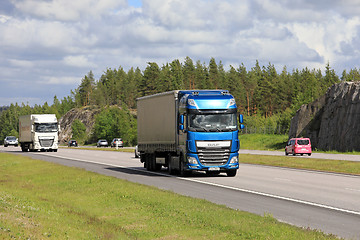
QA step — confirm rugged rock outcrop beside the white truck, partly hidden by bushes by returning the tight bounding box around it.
[59,107,100,144]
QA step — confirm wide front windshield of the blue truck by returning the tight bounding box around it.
[188,113,237,132]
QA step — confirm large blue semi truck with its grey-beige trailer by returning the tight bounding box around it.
[137,90,244,177]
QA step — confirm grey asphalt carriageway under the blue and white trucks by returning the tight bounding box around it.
[0,147,360,239]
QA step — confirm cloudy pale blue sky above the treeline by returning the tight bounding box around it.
[0,0,360,106]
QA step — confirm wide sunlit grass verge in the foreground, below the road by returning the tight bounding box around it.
[0,153,336,239]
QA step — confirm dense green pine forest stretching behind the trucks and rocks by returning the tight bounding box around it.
[0,57,360,145]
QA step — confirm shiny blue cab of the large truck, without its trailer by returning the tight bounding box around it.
[179,90,243,176]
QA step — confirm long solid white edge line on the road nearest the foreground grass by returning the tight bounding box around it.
[37,153,360,216]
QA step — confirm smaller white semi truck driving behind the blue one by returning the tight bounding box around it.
[19,114,59,152]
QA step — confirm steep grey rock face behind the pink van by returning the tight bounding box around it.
[289,82,360,152]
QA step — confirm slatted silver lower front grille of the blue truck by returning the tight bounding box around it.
[198,147,230,166]
